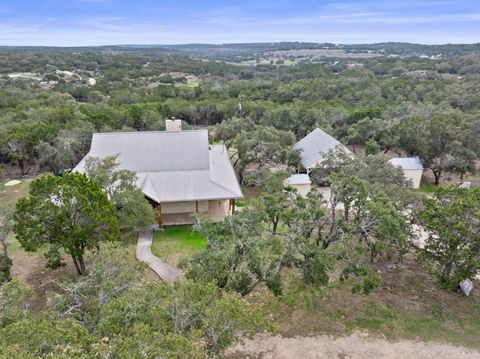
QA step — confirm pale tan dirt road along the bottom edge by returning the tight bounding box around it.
[228,333,480,359]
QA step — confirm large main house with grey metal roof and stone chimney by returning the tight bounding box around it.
[74,120,243,225]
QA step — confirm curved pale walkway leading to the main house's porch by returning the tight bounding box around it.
[136,227,180,283]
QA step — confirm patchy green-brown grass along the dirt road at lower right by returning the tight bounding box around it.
[249,259,480,349]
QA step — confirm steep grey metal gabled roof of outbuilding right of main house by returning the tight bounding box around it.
[292,128,351,174]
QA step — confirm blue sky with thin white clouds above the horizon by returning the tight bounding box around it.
[0,0,480,46]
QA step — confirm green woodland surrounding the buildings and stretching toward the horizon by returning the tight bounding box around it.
[0,43,480,358]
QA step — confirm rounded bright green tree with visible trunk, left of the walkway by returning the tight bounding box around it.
[13,173,119,275]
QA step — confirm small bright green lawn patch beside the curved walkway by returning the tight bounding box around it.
[152,226,207,267]
